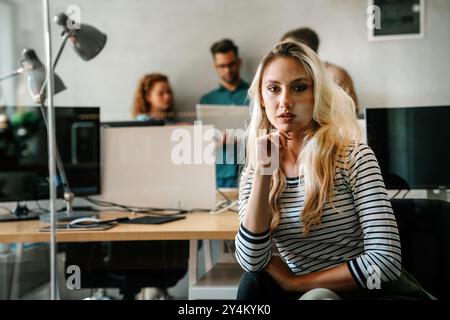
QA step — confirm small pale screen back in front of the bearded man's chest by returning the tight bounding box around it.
[196,104,250,131]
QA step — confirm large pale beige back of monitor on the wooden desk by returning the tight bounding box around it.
[100,123,216,210]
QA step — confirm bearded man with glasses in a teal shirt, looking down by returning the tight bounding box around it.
[199,39,249,188]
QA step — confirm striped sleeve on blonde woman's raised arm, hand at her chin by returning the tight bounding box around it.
[235,169,272,271]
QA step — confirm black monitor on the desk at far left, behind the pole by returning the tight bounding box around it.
[0,107,100,202]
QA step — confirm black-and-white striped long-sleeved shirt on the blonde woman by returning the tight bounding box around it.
[235,144,401,288]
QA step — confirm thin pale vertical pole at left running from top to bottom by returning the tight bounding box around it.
[42,0,59,300]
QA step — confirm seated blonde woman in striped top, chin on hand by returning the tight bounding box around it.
[236,41,426,299]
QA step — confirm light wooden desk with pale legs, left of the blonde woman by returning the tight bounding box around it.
[0,211,239,298]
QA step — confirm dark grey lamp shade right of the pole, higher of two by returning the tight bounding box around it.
[54,13,106,60]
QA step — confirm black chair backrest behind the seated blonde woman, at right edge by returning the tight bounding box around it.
[391,199,450,299]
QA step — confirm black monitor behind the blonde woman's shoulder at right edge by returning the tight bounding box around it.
[366,106,450,189]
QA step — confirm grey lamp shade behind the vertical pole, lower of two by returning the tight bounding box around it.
[20,48,66,101]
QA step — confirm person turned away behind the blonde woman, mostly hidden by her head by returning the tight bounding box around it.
[281,28,359,114]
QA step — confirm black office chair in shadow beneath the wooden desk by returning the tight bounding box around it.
[61,240,189,300]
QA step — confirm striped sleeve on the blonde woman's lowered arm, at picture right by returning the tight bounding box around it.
[347,144,401,289]
